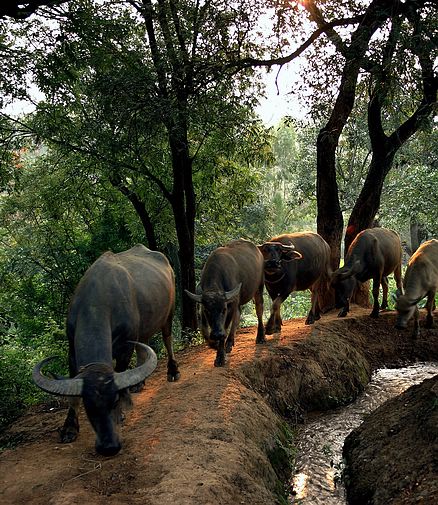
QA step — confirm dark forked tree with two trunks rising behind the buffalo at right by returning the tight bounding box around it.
[296,0,436,268]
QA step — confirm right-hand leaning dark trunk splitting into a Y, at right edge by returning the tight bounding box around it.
[345,5,438,249]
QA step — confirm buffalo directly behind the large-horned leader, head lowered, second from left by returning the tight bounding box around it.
[186,239,265,366]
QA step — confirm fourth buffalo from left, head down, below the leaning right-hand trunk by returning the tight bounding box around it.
[331,228,403,317]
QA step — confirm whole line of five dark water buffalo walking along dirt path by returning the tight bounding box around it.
[33,228,438,456]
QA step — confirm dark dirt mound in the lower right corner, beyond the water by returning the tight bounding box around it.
[344,375,438,505]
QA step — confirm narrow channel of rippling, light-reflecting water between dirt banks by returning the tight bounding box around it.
[290,363,438,505]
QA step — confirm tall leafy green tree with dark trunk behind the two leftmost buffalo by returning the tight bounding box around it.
[4,0,274,328]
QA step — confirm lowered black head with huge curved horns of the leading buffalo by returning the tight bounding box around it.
[32,342,157,456]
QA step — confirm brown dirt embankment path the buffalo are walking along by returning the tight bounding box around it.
[0,309,438,505]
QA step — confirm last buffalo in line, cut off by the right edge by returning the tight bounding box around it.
[396,239,438,337]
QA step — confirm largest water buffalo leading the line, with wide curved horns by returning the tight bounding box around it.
[33,245,179,456]
